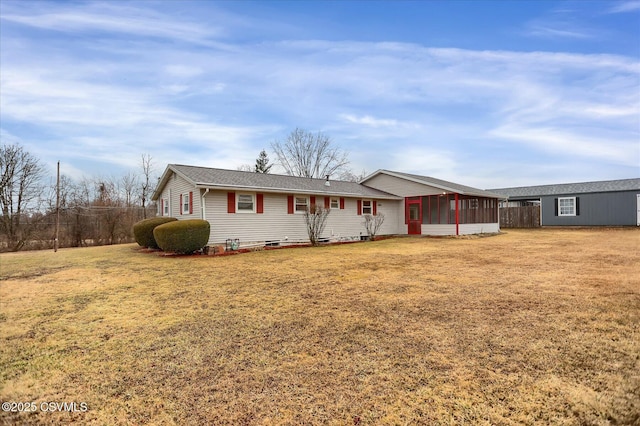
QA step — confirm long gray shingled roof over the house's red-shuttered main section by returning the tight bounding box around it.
[153,164,401,200]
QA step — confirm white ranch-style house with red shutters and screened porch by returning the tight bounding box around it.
[152,164,503,245]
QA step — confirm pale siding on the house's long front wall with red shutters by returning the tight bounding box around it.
[205,191,402,244]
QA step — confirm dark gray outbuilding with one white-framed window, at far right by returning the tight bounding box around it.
[490,178,640,226]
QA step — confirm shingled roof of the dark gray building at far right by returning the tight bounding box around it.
[489,178,640,198]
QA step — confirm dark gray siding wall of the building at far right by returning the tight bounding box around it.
[541,191,639,226]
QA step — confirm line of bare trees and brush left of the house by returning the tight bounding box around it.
[0,144,157,251]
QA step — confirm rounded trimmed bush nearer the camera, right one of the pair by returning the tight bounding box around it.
[153,219,211,254]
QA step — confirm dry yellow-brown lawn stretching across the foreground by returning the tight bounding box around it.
[0,229,640,425]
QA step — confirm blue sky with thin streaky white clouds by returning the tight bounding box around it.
[0,0,640,188]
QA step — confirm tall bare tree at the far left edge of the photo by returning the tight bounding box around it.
[0,144,44,251]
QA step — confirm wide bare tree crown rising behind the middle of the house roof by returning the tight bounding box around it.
[271,128,349,178]
